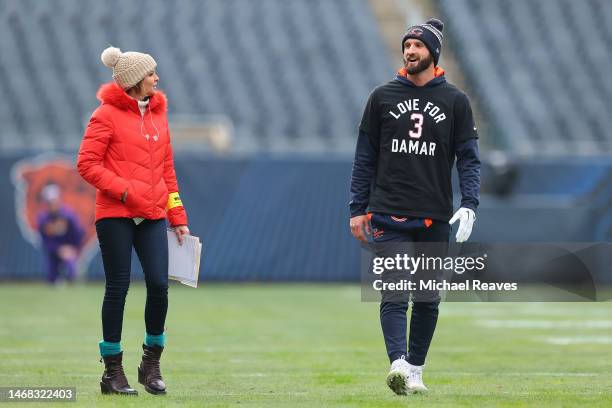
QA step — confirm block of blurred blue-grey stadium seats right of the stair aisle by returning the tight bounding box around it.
[439,0,612,154]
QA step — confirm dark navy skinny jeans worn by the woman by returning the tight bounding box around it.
[96,218,168,343]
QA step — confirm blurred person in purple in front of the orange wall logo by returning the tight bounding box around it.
[37,184,85,284]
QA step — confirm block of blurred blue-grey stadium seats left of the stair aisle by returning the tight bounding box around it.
[0,0,394,152]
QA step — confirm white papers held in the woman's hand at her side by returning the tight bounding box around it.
[168,230,202,288]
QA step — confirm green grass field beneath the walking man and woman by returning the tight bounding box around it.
[0,283,612,407]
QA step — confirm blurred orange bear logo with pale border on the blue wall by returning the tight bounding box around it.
[11,154,97,278]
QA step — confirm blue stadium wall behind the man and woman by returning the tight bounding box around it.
[0,154,612,281]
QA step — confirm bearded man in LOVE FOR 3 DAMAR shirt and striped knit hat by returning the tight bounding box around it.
[350,19,480,394]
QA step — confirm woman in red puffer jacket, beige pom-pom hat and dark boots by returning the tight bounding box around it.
[77,47,189,394]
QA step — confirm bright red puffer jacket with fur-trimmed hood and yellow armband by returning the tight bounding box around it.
[77,82,187,226]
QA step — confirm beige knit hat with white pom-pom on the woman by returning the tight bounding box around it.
[100,47,157,89]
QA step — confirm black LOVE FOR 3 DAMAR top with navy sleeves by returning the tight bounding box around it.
[350,74,480,221]
